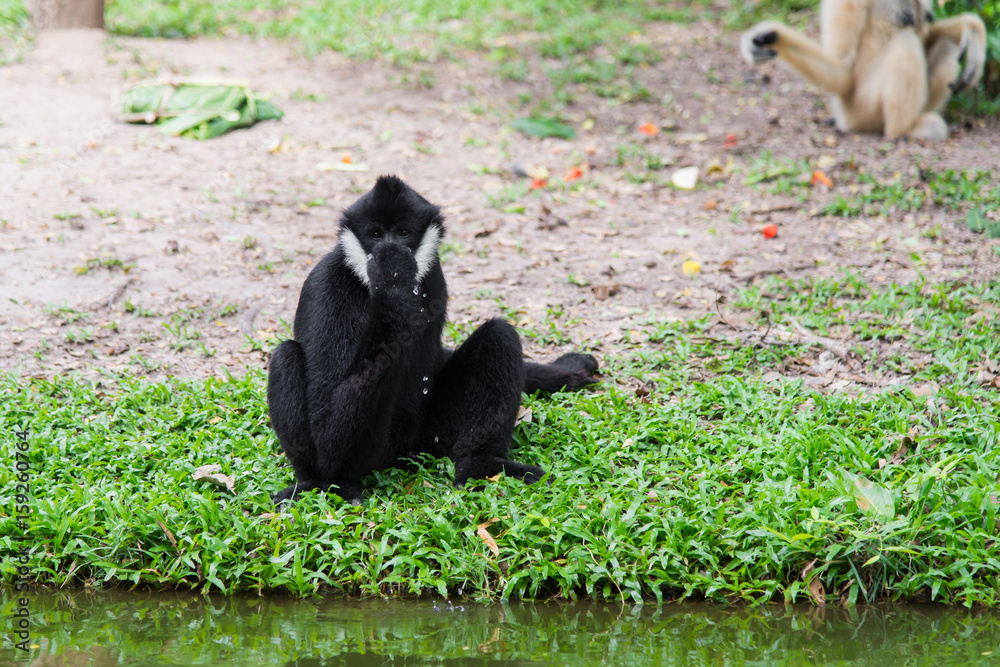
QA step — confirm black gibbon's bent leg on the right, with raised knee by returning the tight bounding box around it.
[421,319,545,487]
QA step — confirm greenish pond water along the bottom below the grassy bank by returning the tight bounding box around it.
[0,588,1000,667]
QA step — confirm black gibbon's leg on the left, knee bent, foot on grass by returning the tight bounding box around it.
[267,340,361,505]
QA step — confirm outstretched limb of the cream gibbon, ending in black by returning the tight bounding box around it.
[740,21,853,96]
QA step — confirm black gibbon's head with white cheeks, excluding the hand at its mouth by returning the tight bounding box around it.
[340,176,444,285]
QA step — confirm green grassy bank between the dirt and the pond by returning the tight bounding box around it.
[0,277,1000,605]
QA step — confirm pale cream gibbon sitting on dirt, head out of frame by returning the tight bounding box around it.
[740,0,986,141]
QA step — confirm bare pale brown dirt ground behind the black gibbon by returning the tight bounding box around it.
[0,23,1000,379]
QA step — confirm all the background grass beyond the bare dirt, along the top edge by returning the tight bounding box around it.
[0,0,1000,116]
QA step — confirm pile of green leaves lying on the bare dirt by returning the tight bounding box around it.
[121,81,284,140]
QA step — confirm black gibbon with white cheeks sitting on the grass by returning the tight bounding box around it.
[267,176,597,504]
